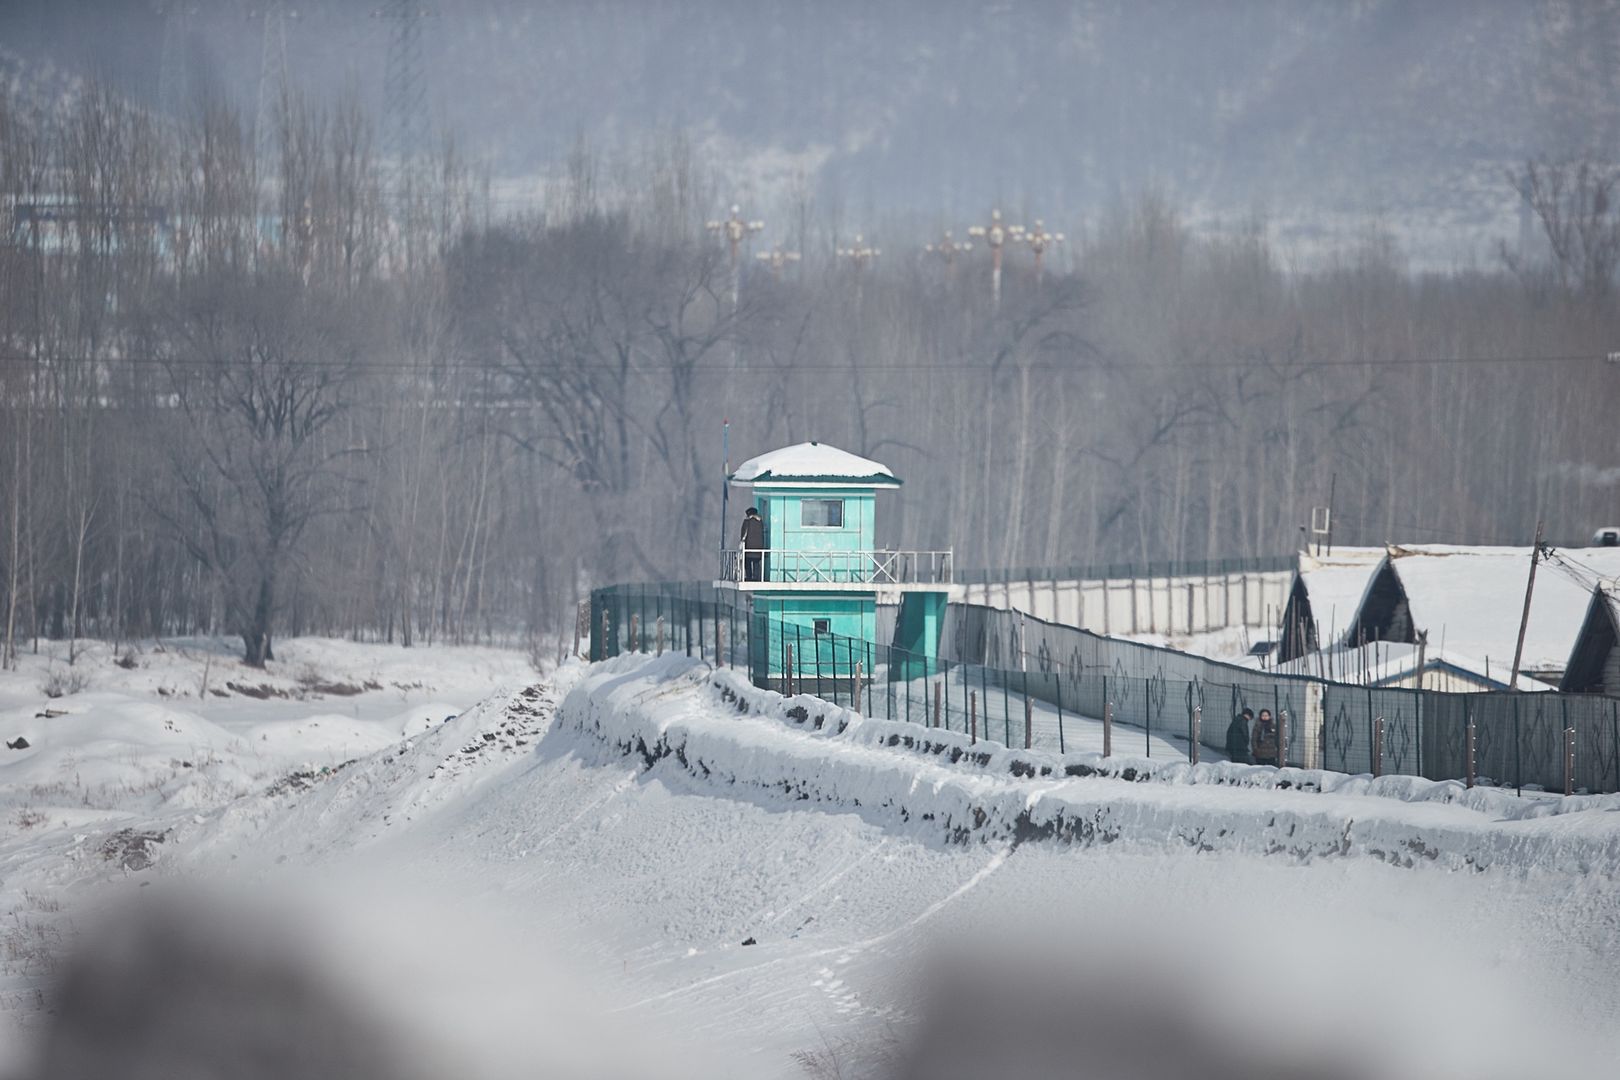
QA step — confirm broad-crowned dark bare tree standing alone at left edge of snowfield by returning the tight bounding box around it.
[156,270,360,667]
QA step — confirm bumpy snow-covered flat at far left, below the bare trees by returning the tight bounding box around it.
[0,638,535,1014]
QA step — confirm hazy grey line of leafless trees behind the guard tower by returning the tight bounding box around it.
[0,87,1620,664]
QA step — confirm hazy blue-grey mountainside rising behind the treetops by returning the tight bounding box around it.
[0,0,1620,259]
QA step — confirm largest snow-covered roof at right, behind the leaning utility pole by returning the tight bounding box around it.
[1390,544,1620,670]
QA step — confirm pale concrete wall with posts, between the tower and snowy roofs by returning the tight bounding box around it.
[962,570,1293,640]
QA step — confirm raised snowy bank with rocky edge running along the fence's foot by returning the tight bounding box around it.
[549,656,1620,874]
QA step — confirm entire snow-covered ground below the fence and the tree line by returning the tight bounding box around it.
[0,641,1620,1077]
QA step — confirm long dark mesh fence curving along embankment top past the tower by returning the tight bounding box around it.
[588,583,1620,792]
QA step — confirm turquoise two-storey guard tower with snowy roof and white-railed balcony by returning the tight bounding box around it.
[716,442,953,685]
